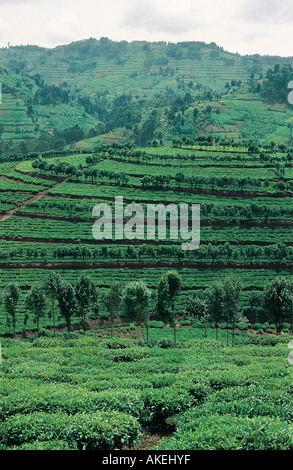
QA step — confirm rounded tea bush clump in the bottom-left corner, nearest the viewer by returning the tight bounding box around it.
[0,412,139,450]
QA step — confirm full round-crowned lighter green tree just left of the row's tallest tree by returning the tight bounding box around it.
[121,281,151,343]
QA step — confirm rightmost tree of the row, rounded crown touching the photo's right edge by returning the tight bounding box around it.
[263,277,293,334]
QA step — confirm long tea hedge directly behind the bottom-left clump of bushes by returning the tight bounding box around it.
[0,384,201,427]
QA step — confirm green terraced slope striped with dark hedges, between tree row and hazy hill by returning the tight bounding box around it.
[0,144,293,334]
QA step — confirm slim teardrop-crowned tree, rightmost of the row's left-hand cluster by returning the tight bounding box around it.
[75,274,97,334]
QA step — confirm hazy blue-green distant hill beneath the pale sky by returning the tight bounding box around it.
[0,37,293,154]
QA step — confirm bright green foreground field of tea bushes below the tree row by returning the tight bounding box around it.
[0,328,293,450]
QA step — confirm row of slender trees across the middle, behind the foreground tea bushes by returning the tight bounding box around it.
[2,270,293,346]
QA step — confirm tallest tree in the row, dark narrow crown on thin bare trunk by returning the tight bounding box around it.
[157,271,182,347]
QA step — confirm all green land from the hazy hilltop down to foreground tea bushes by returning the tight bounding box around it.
[0,38,293,450]
